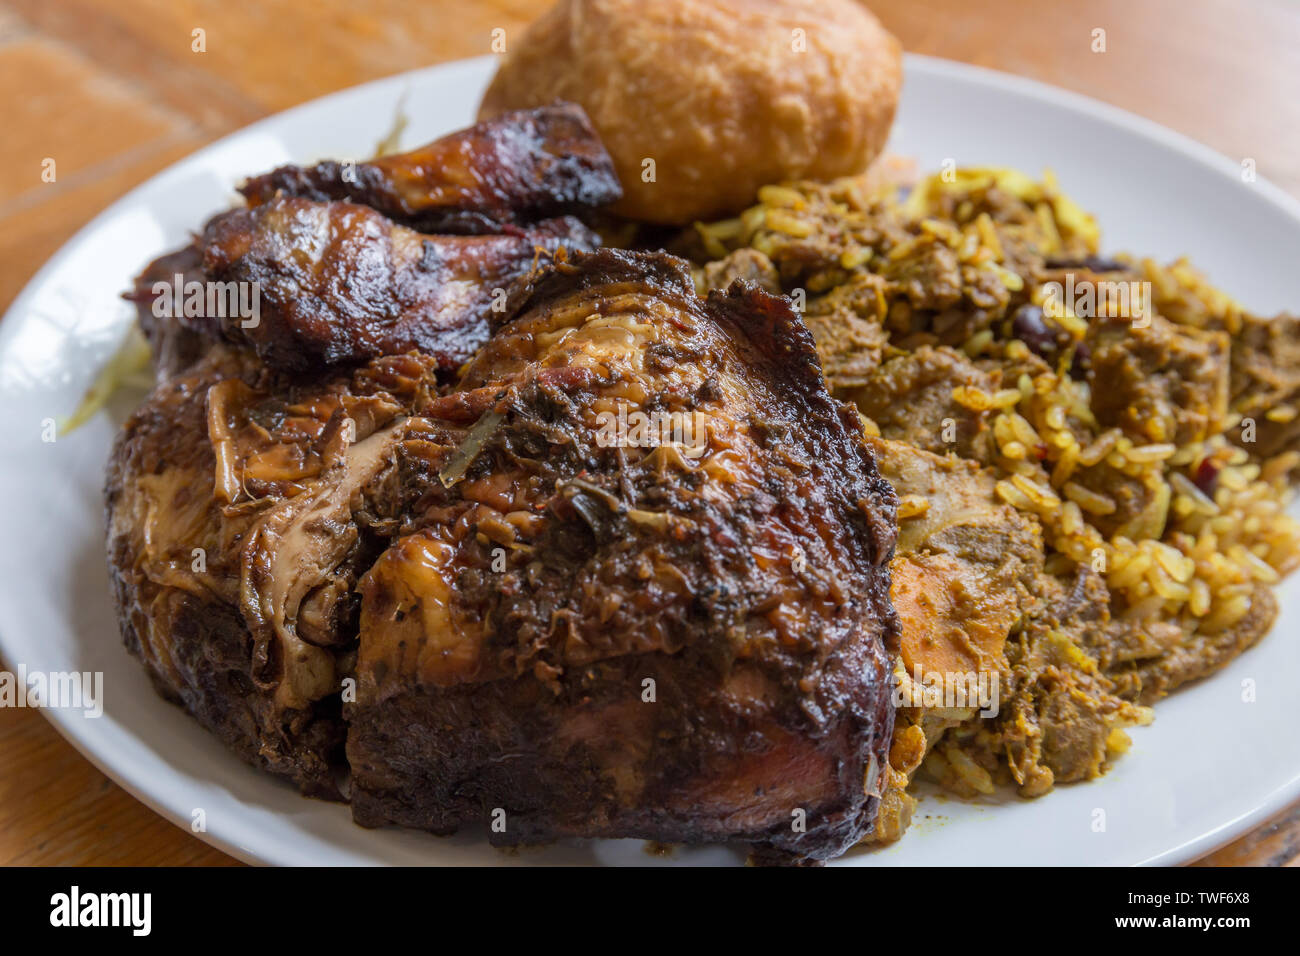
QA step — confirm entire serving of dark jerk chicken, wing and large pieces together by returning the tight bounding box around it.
[105,105,898,861]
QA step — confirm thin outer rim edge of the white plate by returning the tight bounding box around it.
[0,53,1300,866]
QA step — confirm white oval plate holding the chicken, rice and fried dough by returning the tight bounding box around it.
[0,56,1300,865]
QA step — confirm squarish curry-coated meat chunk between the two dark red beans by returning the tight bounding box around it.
[1086,315,1229,445]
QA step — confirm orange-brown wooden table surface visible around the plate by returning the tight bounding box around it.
[0,0,1300,865]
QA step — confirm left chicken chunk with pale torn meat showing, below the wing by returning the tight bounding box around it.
[105,346,436,797]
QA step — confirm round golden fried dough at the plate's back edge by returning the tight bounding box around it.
[478,0,902,224]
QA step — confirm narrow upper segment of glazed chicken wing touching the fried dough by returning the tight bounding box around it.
[239,103,623,234]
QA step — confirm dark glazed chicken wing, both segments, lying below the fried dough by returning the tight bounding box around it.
[127,103,620,378]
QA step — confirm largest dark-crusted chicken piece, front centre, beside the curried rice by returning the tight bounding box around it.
[347,251,896,860]
